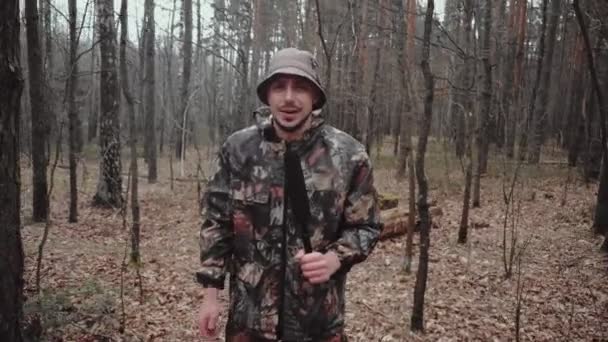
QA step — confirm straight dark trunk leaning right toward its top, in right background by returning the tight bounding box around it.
[528,0,561,164]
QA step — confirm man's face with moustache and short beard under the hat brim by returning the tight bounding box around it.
[268,74,318,133]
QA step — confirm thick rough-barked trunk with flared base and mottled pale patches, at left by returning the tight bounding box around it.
[93,0,123,208]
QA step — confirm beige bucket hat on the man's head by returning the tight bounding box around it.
[257,48,327,110]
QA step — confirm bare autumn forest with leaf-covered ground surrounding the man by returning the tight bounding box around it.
[0,0,608,342]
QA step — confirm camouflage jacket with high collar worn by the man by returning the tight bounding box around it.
[197,111,381,341]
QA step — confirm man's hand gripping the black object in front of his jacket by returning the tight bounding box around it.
[296,250,340,284]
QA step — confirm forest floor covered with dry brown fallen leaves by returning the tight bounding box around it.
[22,143,608,341]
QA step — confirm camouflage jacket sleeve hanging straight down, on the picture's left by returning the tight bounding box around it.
[196,147,233,289]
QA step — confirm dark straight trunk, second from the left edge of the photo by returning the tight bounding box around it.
[25,0,50,222]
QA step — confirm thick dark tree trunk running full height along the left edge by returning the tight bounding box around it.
[0,0,24,342]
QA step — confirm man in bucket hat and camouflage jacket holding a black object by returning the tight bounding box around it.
[197,48,381,342]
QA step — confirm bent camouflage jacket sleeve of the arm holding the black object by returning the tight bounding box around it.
[328,151,382,273]
